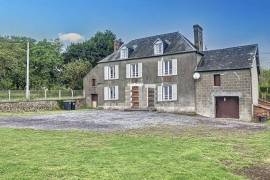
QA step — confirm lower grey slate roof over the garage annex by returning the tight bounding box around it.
[196,44,259,71]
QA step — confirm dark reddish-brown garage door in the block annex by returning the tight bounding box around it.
[216,96,239,119]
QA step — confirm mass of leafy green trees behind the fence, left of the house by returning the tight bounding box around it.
[0,30,116,90]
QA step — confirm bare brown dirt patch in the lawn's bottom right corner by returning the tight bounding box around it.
[241,164,270,180]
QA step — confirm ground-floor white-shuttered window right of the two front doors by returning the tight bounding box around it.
[158,84,177,101]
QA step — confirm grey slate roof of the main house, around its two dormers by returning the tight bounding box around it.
[100,32,196,63]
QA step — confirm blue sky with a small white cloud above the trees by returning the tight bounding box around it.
[0,0,270,68]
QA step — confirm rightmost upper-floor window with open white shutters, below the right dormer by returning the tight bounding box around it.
[158,58,177,76]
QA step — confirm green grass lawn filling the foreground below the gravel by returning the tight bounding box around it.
[0,127,270,179]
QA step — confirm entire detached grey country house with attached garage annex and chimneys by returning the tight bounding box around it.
[84,25,260,121]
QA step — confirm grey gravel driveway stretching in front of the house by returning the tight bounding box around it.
[0,110,265,131]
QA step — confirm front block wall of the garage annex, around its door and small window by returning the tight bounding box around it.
[196,69,253,121]
